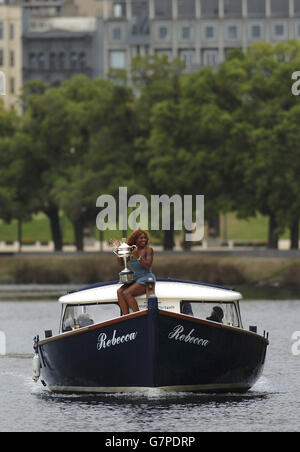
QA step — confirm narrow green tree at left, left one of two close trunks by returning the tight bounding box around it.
[15,82,72,251]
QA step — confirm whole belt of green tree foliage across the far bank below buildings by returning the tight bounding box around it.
[0,41,300,248]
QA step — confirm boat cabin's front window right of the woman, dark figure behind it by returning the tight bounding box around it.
[180,301,240,327]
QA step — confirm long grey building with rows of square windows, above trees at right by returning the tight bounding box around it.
[103,0,300,73]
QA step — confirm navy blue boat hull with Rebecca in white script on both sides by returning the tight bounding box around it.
[39,310,268,392]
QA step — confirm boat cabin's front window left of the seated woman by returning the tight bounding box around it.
[62,303,120,332]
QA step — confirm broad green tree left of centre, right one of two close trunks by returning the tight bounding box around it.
[55,77,134,251]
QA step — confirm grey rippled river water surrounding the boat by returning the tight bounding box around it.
[0,294,300,433]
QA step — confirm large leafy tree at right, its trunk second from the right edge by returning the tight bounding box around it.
[217,42,300,248]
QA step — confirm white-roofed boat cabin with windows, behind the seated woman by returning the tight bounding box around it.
[59,279,243,333]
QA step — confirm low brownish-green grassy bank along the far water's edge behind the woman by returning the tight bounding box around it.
[0,254,300,290]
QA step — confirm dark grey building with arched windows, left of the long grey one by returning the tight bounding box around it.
[23,17,104,86]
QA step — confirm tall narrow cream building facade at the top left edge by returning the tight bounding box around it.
[0,3,23,111]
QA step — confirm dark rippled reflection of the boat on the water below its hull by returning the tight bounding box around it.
[27,380,274,432]
